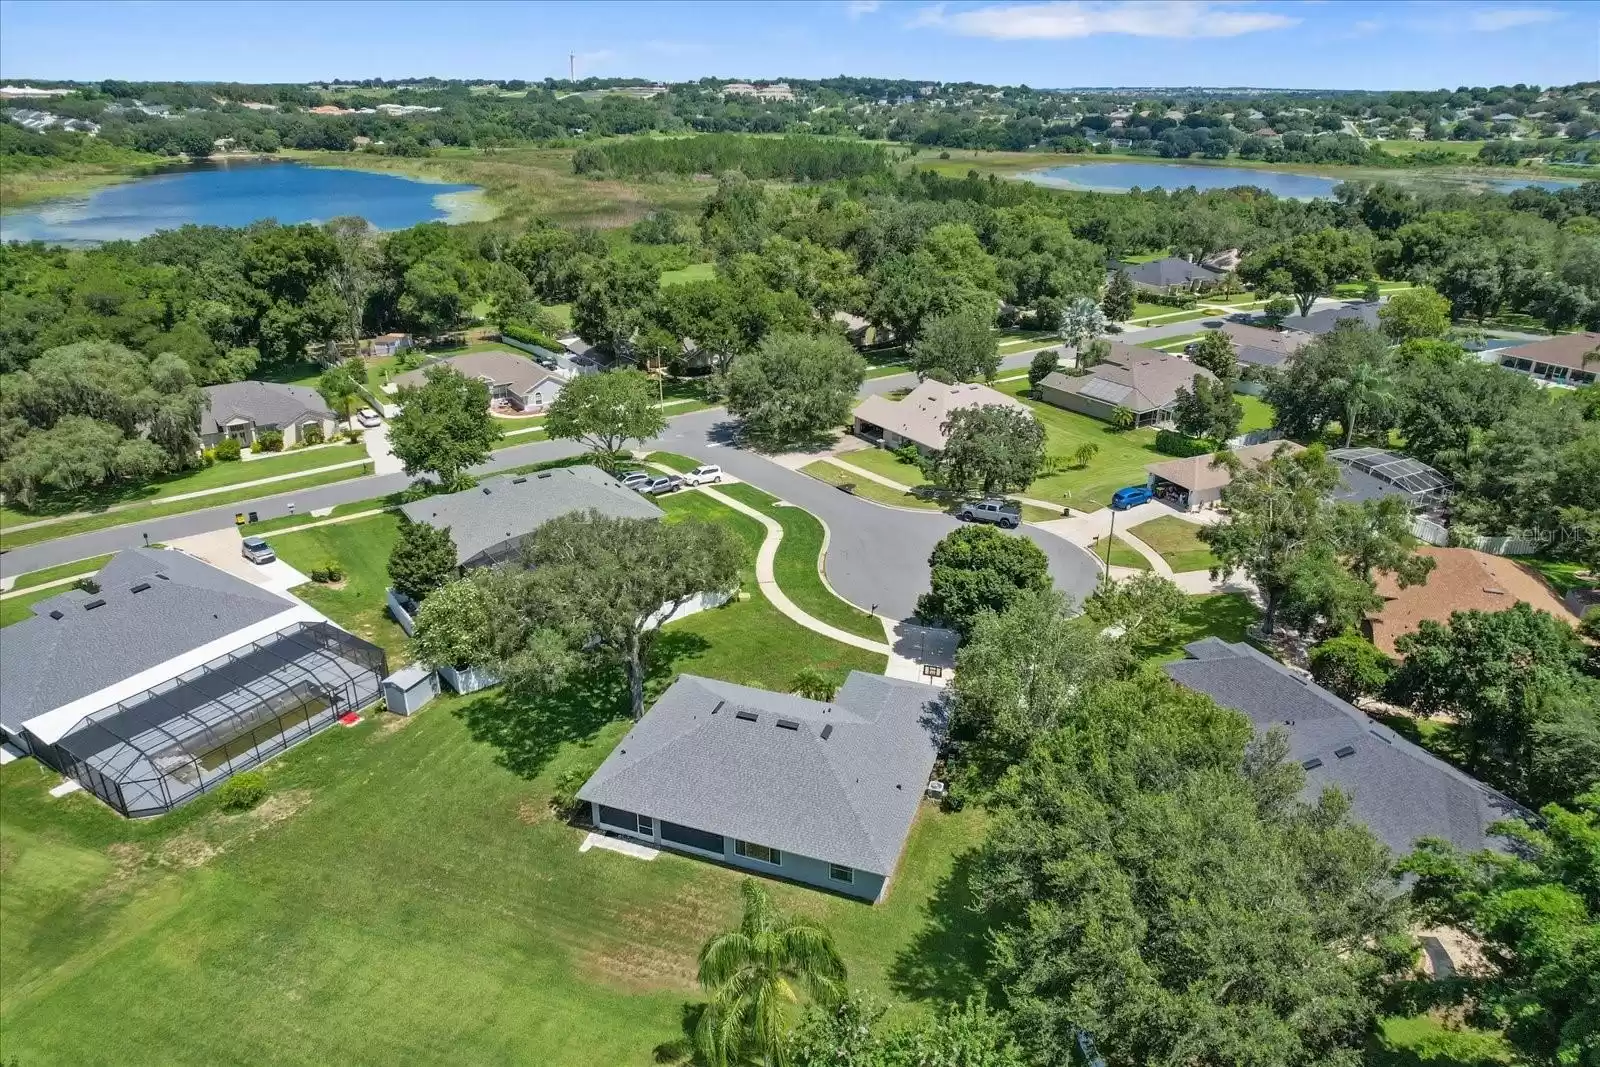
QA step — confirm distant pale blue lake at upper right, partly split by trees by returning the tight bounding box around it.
[1018,163,1578,200]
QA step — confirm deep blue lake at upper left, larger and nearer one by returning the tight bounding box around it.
[0,162,482,245]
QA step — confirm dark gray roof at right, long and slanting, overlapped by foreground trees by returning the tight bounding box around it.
[1165,637,1525,856]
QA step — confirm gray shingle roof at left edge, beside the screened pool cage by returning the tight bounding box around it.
[0,549,294,729]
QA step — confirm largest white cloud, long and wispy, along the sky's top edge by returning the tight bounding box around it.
[910,0,1299,40]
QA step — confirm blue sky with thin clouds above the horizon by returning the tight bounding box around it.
[0,0,1600,88]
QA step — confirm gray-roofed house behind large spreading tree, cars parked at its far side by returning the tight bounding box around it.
[400,466,661,569]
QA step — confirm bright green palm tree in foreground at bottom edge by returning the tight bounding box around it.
[694,880,845,1067]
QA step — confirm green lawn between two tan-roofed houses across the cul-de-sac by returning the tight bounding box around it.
[995,379,1166,512]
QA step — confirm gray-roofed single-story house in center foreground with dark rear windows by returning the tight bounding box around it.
[578,670,944,902]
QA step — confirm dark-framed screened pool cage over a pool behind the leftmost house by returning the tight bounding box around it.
[35,621,389,817]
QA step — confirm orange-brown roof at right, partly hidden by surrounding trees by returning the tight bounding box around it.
[1362,545,1579,656]
